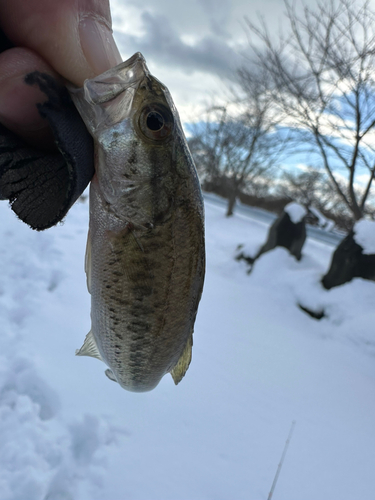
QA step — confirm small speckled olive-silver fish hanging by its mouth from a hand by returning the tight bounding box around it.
[69,52,205,392]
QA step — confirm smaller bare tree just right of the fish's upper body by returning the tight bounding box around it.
[188,70,283,216]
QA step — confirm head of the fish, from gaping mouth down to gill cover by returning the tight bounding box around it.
[69,52,196,223]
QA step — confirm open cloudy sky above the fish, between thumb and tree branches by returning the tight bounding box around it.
[111,0,284,122]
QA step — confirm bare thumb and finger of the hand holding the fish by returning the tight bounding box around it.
[0,0,121,149]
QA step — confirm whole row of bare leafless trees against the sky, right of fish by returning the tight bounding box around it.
[189,0,375,228]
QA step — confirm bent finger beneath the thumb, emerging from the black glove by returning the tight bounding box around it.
[0,48,57,150]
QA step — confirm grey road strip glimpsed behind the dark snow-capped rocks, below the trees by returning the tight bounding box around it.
[203,192,345,247]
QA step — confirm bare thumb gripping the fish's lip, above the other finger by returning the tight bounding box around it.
[0,0,121,86]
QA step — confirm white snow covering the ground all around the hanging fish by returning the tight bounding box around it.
[0,195,375,500]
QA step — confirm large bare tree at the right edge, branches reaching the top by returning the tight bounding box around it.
[244,0,375,220]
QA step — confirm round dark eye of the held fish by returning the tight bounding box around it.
[138,104,173,142]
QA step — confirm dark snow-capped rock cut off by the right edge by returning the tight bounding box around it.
[322,231,375,290]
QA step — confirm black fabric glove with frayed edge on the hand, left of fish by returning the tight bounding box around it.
[0,32,94,230]
